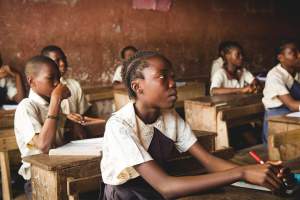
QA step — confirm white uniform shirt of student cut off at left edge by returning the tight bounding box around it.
[0,77,17,105]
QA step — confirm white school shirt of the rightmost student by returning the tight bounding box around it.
[262,63,300,108]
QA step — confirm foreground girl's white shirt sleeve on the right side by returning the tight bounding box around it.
[174,111,197,152]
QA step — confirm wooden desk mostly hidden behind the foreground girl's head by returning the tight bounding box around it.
[113,81,205,110]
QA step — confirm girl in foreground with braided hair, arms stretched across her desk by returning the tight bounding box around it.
[101,52,283,200]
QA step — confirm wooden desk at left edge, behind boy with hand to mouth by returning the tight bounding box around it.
[0,110,18,200]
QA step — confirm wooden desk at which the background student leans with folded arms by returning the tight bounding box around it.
[184,95,264,150]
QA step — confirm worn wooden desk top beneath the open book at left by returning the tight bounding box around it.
[23,154,100,171]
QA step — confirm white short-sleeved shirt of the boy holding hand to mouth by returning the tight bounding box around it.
[14,90,66,180]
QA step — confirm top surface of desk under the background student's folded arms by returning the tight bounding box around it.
[187,94,262,106]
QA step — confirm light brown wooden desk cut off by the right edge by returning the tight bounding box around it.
[268,115,300,160]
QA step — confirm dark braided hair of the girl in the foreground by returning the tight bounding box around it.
[122,51,172,98]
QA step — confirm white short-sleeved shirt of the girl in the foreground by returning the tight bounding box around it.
[101,102,197,185]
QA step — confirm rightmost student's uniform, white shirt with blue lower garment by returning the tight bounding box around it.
[262,63,300,144]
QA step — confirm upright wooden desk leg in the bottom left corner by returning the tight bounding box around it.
[0,151,12,200]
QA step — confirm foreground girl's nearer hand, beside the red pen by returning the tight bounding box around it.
[242,163,283,191]
